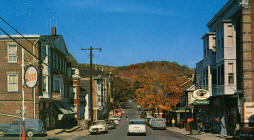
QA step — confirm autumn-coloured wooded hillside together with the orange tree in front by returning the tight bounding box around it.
[112,61,193,112]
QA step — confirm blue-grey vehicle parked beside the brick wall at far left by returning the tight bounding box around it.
[0,119,47,137]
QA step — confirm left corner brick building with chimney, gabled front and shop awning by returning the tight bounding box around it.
[0,27,75,128]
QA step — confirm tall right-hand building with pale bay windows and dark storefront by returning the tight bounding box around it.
[196,0,254,134]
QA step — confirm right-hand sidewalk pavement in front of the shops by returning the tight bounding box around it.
[167,127,232,140]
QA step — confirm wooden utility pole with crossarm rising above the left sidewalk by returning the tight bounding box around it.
[81,46,101,121]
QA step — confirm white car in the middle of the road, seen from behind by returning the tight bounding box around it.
[127,119,146,136]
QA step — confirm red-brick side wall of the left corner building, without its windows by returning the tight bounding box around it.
[0,39,39,123]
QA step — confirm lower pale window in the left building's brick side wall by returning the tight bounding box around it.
[7,73,18,92]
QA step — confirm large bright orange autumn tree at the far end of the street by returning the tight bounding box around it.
[135,67,185,117]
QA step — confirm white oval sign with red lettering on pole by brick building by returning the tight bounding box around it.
[24,65,38,88]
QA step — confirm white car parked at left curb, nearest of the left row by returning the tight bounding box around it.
[89,120,108,134]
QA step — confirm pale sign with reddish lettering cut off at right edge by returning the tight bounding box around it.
[243,102,254,123]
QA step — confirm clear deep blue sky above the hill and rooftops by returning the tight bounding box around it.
[0,0,228,68]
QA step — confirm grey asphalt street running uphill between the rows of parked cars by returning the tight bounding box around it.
[0,103,195,140]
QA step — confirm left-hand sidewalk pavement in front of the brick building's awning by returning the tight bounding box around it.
[47,126,90,137]
